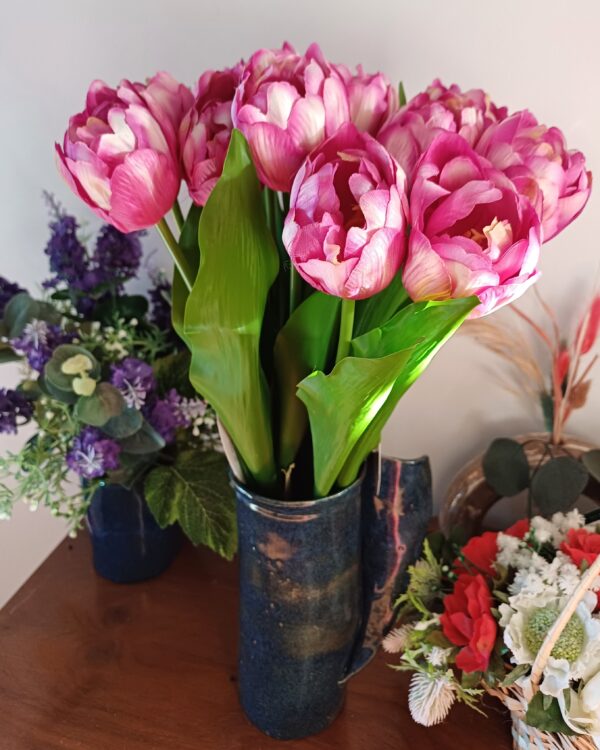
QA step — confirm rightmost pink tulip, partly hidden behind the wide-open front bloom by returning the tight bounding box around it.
[476,111,592,242]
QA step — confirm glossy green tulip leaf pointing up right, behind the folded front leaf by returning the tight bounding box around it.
[338,297,479,487]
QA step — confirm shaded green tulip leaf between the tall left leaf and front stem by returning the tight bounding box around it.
[274,292,341,469]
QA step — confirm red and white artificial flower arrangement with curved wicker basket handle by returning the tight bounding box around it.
[384,510,600,748]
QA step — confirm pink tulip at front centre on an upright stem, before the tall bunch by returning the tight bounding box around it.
[283,123,407,299]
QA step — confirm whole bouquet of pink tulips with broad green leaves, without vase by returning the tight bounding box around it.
[56,44,591,499]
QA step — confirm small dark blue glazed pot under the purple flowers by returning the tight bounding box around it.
[87,484,181,583]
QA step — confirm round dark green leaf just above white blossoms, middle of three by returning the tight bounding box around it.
[531,456,589,515]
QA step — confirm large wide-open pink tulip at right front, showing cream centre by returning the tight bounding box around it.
[403,132,541,317]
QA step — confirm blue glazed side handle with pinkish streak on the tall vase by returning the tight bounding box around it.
[341,452,432,682]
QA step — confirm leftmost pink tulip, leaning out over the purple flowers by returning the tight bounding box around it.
[56,73,193,232]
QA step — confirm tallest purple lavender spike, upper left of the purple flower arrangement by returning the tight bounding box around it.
[44,213,87,289]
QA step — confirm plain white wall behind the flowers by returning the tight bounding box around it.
[0,0,600,604]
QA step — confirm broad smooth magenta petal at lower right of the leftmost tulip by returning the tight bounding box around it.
[110,150,179,232]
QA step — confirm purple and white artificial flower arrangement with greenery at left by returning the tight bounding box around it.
[0,199,235,557]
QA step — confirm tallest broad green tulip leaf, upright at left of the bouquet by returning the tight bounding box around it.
[184,130,279,490]
